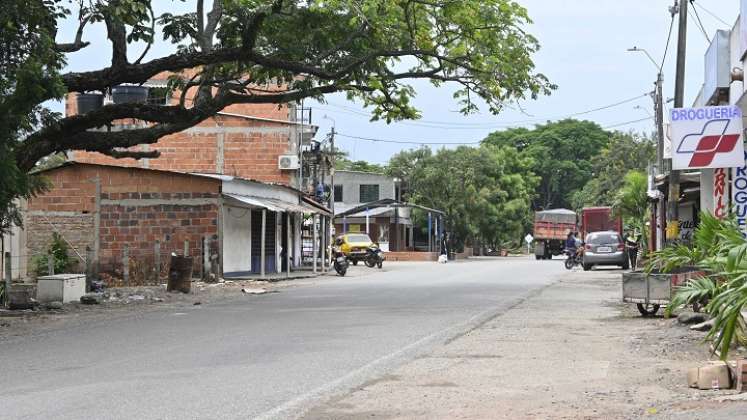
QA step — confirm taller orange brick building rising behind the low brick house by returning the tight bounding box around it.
[65,75,317,187]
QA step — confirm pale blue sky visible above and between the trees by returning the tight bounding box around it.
[56,0,740,163]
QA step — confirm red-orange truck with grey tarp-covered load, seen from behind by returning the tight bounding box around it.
[534,209,576,260]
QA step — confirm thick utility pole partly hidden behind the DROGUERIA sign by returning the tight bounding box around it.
[667,0,688,241]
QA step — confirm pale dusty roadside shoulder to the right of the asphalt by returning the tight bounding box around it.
[306,271,747,419]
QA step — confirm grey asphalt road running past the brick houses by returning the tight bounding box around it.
[0,258,565,419]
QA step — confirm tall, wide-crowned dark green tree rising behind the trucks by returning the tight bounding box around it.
[483,119,610,210]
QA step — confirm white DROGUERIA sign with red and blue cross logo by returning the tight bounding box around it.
[669,106,744,169]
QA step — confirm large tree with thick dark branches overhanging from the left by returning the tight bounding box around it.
[0,0,554,220]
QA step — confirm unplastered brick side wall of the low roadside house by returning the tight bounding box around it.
[26,164,221,279]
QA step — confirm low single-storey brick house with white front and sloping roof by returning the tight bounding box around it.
[23,162,326,280]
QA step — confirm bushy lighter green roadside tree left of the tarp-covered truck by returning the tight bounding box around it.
[400,145,537,248]
